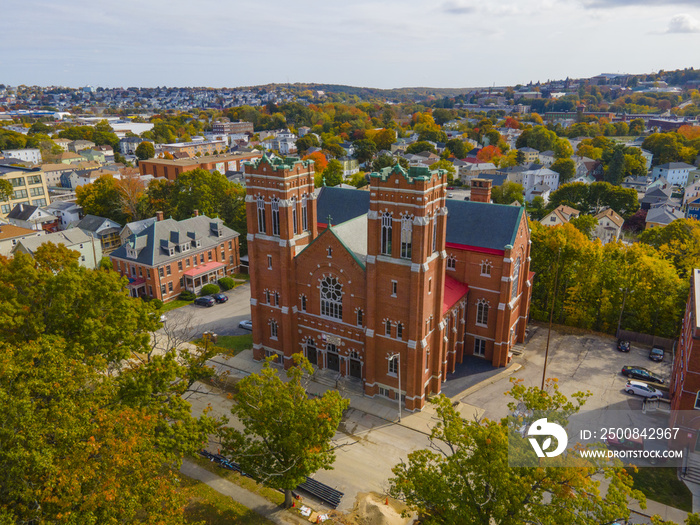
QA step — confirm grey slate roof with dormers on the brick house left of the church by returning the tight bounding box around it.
[110,215,239,266]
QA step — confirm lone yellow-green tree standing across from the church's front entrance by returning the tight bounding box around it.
[221,354,349,507]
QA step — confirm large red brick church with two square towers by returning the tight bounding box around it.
[245,155,532,410]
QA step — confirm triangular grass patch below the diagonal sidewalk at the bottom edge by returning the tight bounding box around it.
[182,476,272,525]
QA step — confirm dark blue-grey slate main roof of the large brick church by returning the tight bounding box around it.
[318,187,523,251]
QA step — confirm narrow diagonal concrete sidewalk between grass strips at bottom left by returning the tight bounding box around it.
[180,459,308,525]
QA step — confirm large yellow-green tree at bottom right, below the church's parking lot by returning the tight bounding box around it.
[390,382,644,525]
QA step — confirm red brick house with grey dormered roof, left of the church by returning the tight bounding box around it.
[109,212,240,301]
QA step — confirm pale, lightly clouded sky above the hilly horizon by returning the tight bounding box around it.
[0,0,700,88]
